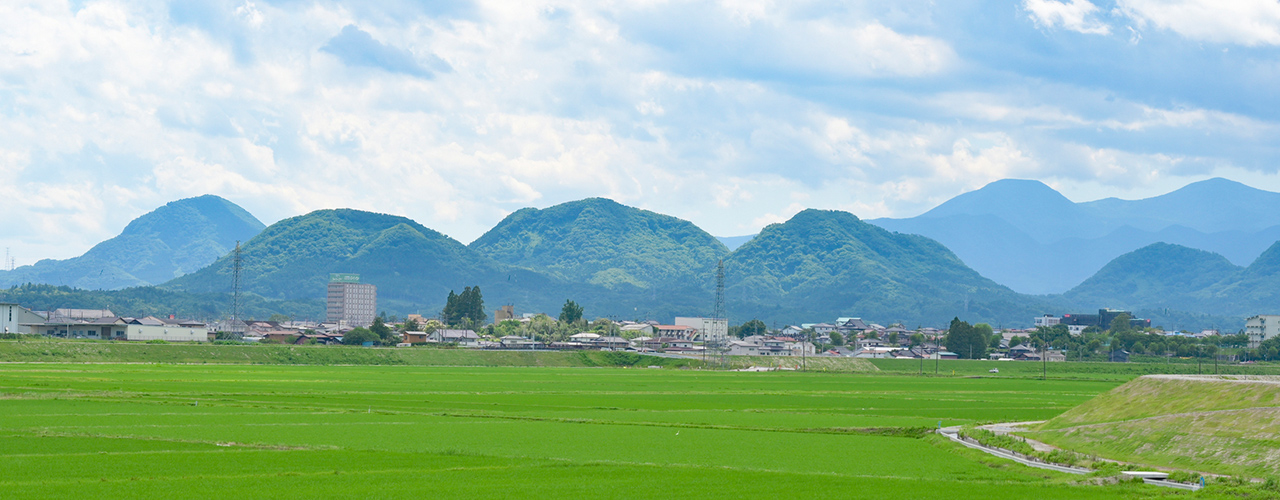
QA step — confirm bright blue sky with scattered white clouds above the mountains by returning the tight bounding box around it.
[0,0,1280,266]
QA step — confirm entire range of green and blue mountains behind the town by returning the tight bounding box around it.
[10,179,1280,329]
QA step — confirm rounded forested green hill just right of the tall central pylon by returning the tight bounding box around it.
[724,210,1044,326]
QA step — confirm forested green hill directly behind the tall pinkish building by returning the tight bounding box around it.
[164,210,666,319]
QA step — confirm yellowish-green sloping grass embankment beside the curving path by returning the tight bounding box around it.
[1028,375,1280,477]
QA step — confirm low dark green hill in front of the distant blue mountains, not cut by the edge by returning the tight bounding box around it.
[1064,243,1240,309]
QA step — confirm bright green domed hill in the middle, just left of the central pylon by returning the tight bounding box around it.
[471,198,728,289]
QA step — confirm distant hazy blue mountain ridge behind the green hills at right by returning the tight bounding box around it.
[869,179,1280,294]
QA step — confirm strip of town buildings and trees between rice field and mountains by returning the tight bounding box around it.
[0,269,1280,362]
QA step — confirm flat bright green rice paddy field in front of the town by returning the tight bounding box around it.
[0,363,1259,499]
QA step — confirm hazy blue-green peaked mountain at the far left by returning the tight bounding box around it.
[0,194,264,290]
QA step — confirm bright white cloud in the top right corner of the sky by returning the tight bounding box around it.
[1117,0,1280,46]
